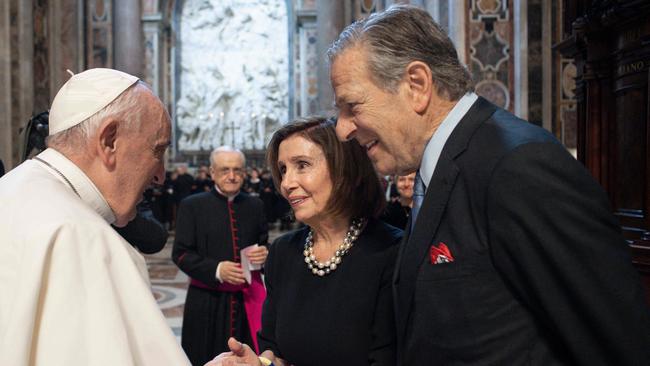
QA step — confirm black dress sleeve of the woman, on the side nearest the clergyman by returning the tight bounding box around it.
[257,240,282,357]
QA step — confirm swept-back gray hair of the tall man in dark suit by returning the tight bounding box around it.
[327,5,474,100]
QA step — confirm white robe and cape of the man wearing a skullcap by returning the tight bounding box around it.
[0,149,189,366]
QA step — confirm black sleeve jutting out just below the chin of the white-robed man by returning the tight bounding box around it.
[115,212,169,254]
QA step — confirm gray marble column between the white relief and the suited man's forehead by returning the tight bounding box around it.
[316,0,347,113]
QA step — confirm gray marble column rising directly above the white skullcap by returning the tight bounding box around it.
[113,0,144,77]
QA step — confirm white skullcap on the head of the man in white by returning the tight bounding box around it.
[49,68,139,136]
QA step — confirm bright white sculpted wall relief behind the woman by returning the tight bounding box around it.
[176,0,289,152]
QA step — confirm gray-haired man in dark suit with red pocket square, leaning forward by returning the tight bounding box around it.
[328,6,650,365]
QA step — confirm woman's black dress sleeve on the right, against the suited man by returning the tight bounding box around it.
[368,242,401,366]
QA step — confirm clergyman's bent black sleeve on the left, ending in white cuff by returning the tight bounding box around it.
[172,200,219,286]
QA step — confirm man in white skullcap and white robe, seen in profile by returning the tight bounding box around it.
[0,69,189,366]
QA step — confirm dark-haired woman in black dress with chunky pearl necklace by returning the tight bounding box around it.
[210,118,402,366]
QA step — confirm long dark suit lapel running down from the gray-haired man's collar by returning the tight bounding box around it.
[393,97,496,339]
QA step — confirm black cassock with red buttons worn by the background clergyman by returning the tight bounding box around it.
[172,148,268,365]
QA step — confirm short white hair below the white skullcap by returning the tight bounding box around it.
[46,81,149,153]
